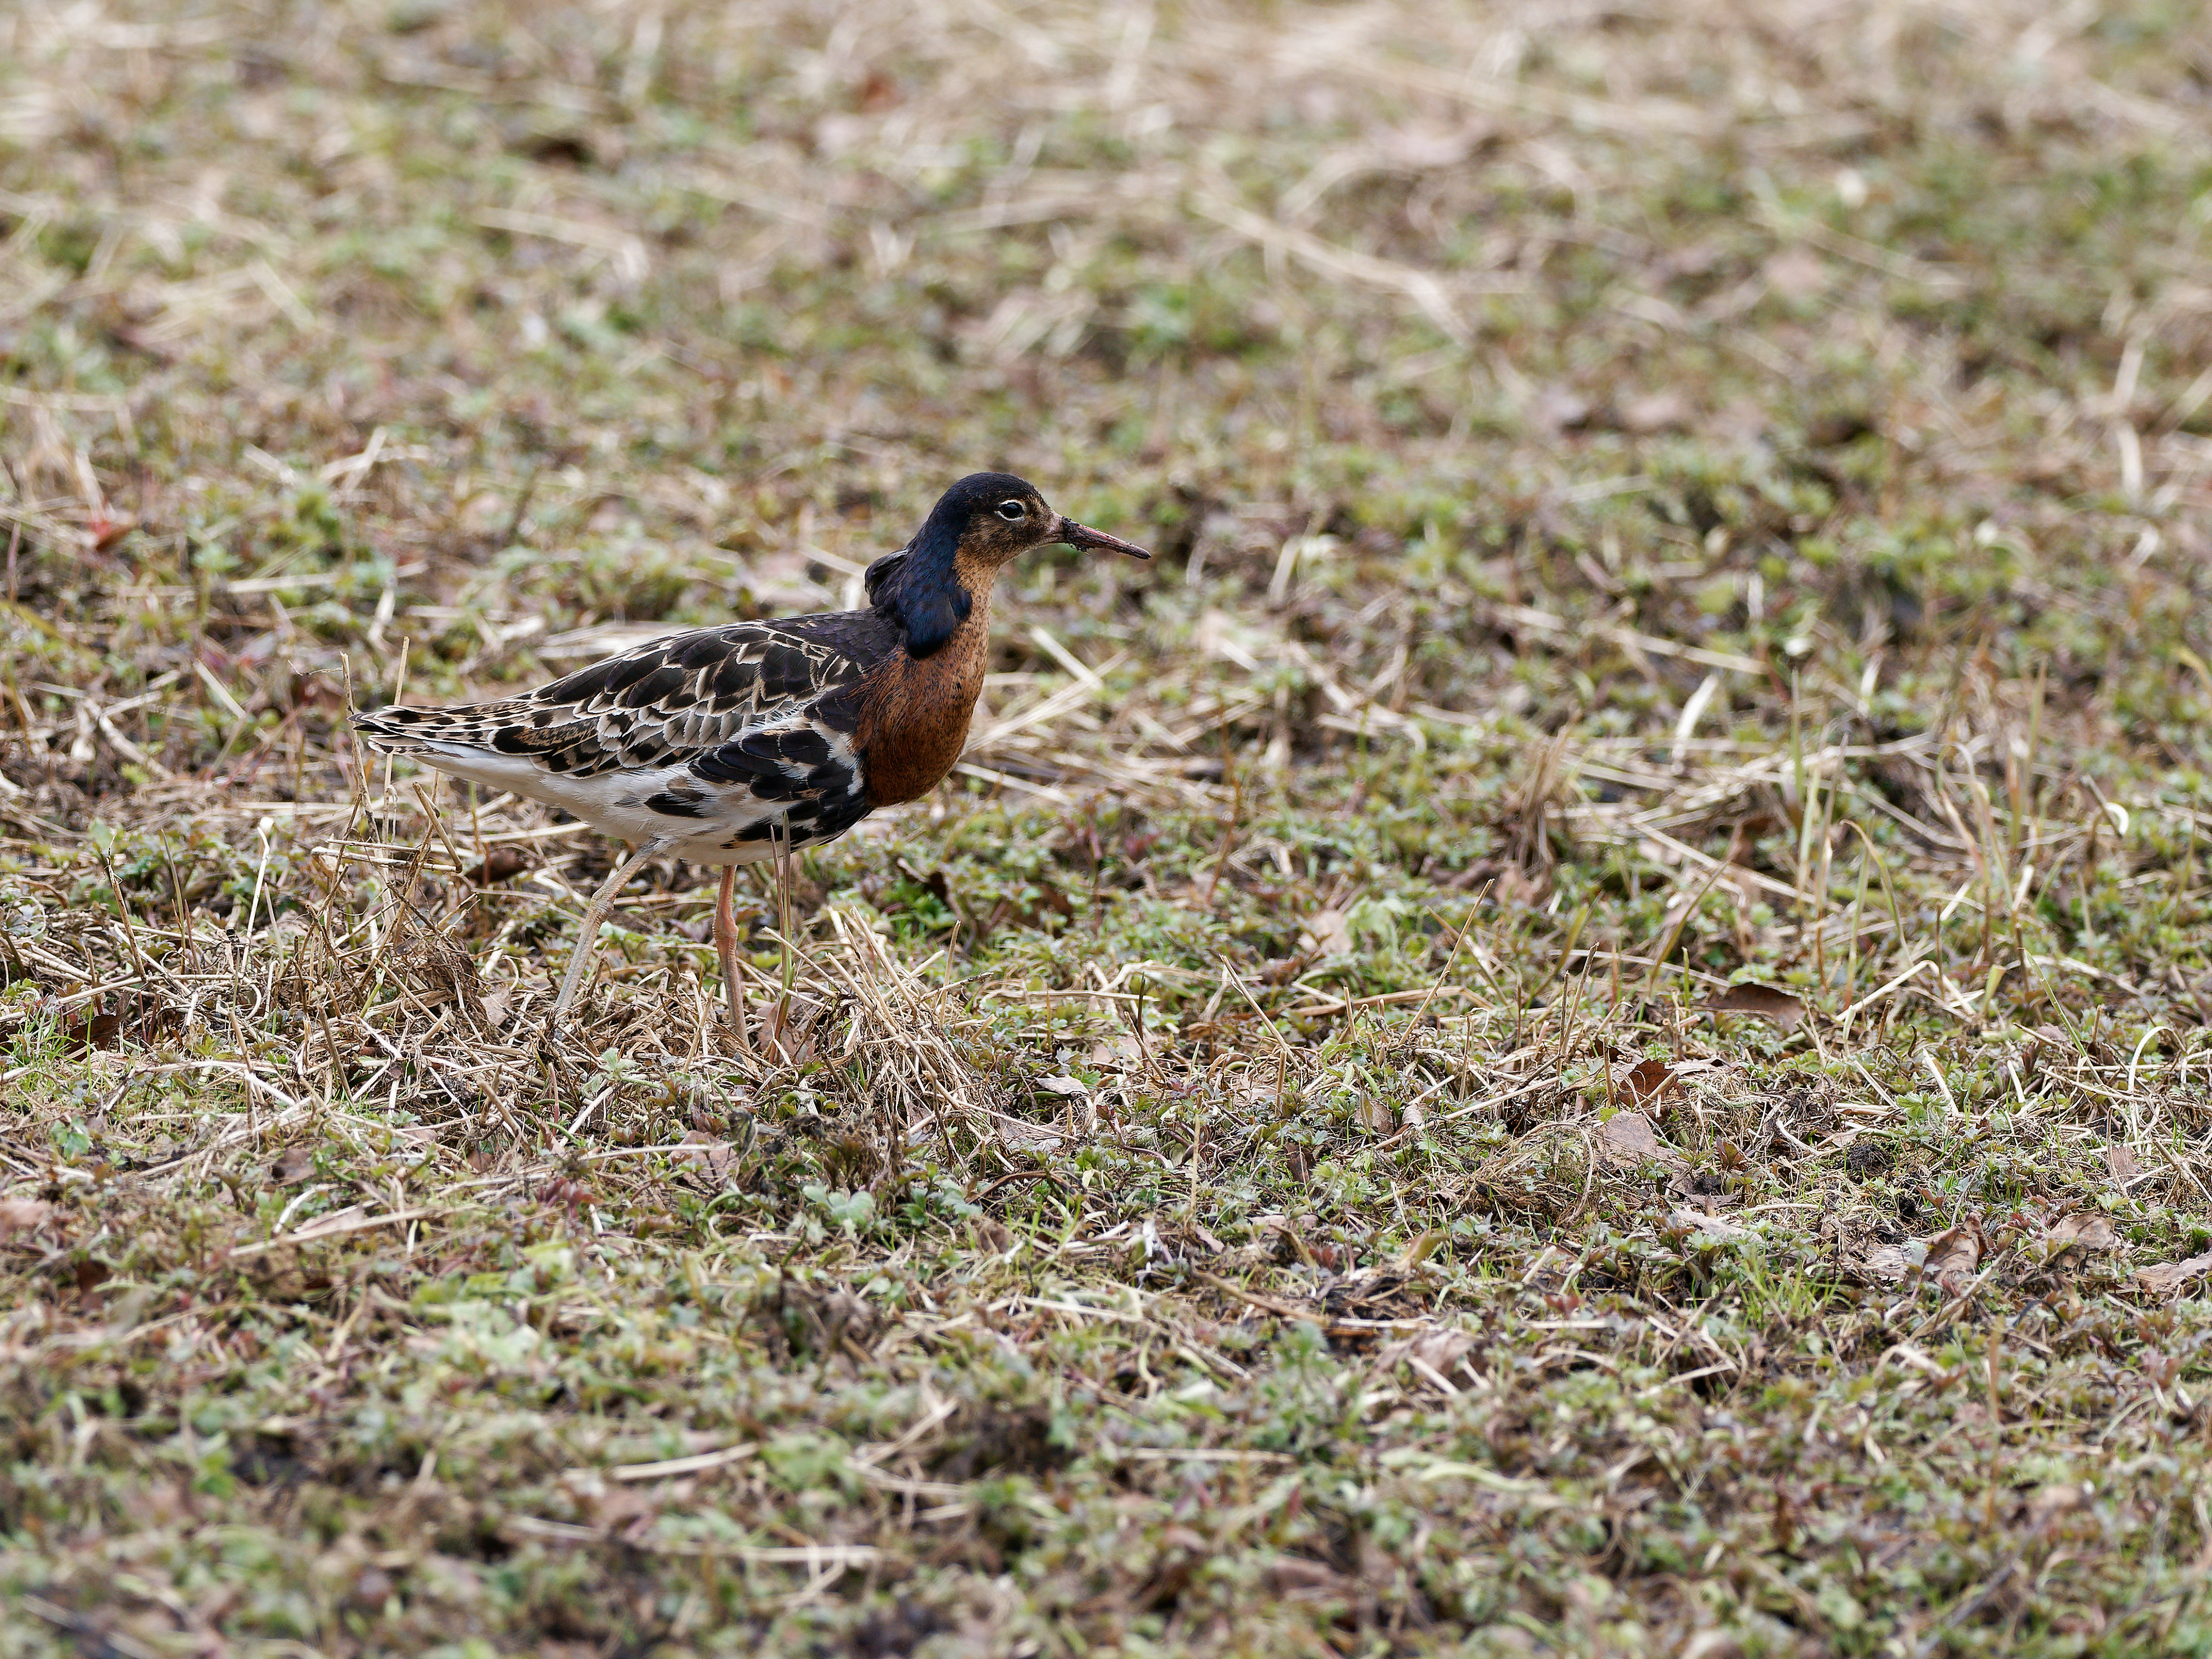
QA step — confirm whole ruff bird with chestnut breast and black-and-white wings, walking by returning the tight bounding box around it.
[352,473,1152,1042]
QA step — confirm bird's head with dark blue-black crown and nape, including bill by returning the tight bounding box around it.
[867,473,1152,657]
